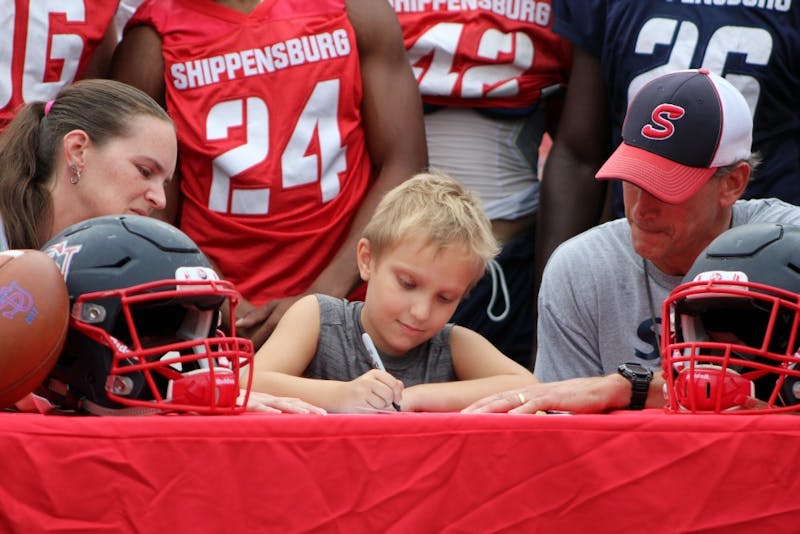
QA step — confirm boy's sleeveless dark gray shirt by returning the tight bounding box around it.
[298,295,457,387]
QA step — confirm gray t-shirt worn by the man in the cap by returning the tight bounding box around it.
[534,199,800,382]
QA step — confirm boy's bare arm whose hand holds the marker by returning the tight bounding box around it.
[252,295,402,412]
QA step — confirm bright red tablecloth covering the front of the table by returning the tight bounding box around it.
[0,410,800,534]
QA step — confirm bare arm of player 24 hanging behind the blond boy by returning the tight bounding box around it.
[237,0,428,347]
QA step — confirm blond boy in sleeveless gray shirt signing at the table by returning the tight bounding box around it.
[248,173,535,412]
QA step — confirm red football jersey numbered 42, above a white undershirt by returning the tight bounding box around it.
[389,0,571,108]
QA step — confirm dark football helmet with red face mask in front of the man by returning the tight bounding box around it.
[661,223,800,413]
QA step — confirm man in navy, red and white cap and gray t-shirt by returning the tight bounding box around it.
[467,69,800,412]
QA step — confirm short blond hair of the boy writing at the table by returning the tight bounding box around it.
[363,171,500,280]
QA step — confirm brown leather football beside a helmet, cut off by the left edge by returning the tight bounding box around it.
[0,250,69,409]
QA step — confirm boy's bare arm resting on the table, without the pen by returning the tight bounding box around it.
[402,326,537,412]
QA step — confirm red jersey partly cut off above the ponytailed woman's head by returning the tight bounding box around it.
[0,0,118,130]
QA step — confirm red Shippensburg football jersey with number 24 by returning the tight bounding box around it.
[129,0,371,304]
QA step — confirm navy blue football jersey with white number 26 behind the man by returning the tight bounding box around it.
[553,0,800,204]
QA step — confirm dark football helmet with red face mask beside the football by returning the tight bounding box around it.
[39,215,253,414]
